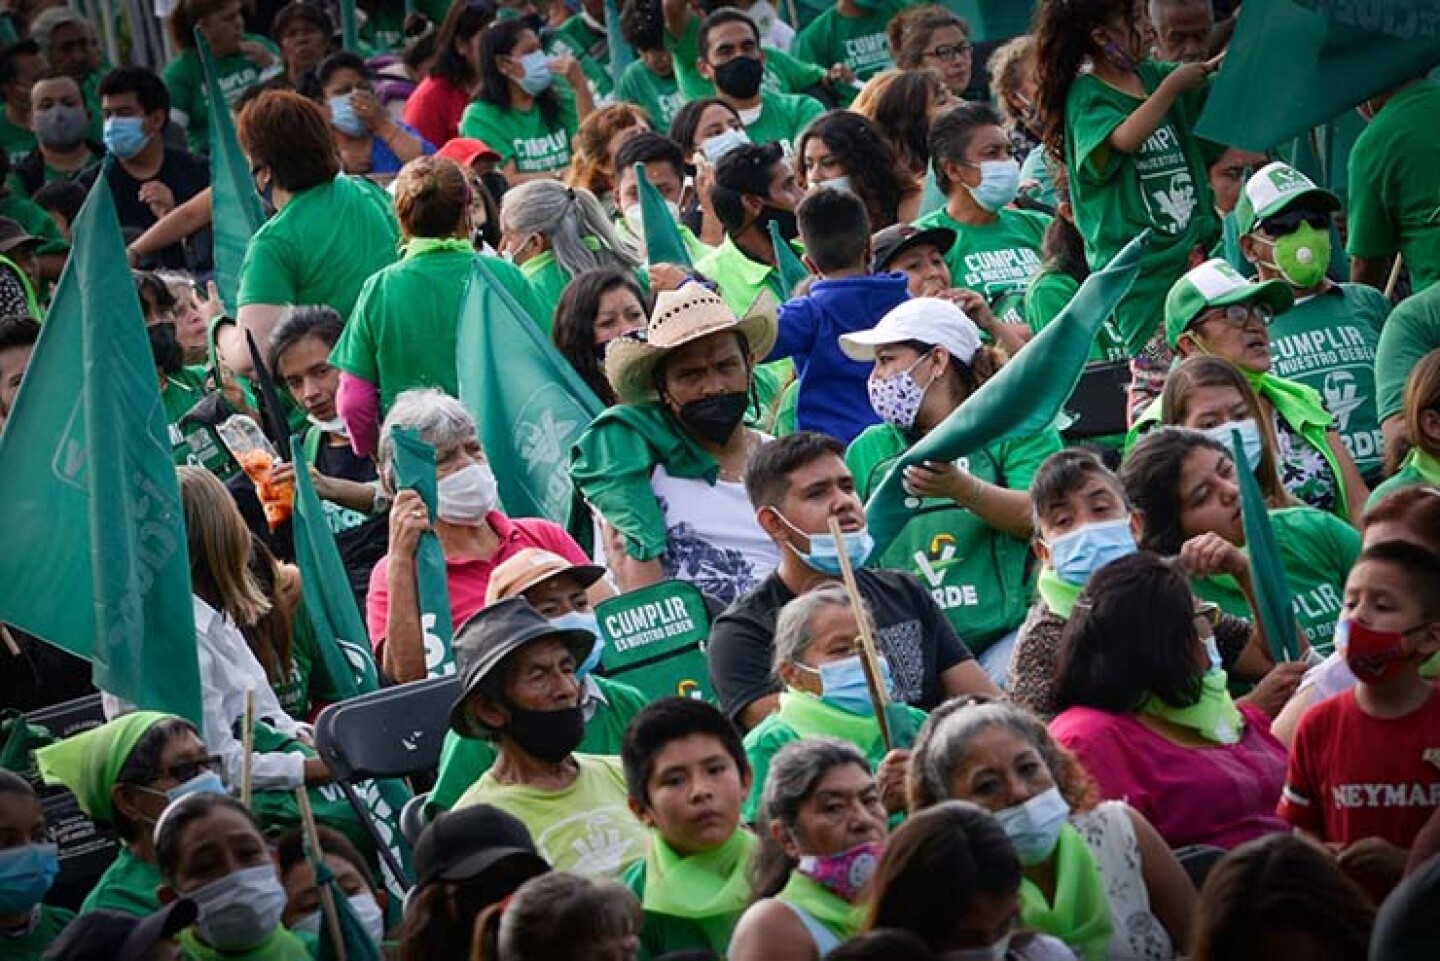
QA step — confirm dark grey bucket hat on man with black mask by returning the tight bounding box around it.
[451,598,595,738]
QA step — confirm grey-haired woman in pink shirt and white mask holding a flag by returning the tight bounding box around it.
[366,390,605,683]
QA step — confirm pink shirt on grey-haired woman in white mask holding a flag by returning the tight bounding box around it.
[366,510,590,662]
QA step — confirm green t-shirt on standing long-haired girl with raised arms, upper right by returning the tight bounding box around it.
[1066,61,1220,354]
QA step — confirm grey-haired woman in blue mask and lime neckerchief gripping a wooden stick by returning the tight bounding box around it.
[742,584,926,821]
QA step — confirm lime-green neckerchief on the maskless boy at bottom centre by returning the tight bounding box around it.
[641,828,760,954]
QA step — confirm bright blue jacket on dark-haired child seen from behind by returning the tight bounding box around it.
[768,274,910,444]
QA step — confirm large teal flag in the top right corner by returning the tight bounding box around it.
[1197,0,1440,150]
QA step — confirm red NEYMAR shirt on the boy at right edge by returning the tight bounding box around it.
[1279,690,1440,847]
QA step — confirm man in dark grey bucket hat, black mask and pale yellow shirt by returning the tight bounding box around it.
[449,598,647,876]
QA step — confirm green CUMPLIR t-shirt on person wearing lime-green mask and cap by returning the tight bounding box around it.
[1270,284,1390,483]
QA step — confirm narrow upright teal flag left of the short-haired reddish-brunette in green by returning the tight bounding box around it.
[194,27,265,317]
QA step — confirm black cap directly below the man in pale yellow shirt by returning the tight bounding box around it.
[415,804,550,886]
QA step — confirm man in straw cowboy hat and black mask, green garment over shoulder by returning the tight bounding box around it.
[570,282,779,604]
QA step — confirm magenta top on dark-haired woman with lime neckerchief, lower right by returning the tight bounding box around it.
[1050,705,1290,849]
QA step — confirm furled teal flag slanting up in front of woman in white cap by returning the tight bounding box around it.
[865,231,1151,558]
